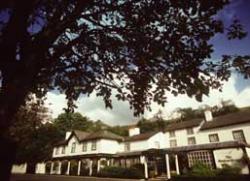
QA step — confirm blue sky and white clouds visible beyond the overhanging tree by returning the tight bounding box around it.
[46,0,250,125]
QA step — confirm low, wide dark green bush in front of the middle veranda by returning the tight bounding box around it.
[98,167,144,179]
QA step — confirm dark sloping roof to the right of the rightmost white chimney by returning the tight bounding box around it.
[201,110,250,130]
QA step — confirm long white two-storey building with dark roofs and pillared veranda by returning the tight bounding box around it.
[12,111,250,178]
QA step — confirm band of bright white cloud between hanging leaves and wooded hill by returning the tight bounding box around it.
[44,73,250,125]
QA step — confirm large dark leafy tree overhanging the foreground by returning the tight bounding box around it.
[0,0,244,180]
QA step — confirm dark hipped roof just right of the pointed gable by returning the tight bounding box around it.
[84,130,123,141]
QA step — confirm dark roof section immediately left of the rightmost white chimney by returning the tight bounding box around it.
[165,118,203,131]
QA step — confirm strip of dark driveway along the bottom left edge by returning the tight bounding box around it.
[11,174,143,181]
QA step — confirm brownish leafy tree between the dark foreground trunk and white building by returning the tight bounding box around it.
[9,97,60,163]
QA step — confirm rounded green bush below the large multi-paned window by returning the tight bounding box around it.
[189,162,216,176]
